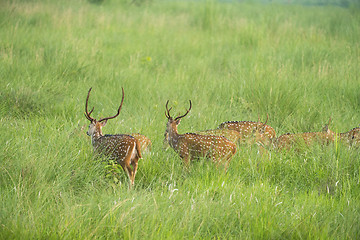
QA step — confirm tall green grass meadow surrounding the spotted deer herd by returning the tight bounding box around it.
[0,0,360,239]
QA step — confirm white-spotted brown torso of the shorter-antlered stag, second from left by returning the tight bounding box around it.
[177,133,236,162]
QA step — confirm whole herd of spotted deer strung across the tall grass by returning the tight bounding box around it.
[85,88,360,188]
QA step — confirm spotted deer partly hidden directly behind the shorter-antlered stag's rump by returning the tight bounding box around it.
[218,115,276,145]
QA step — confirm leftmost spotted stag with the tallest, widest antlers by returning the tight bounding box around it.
[85,88,141,188]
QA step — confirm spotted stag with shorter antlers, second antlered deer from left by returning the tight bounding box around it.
[164,100,236,170]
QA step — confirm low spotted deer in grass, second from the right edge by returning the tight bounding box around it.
[275,118,335,149]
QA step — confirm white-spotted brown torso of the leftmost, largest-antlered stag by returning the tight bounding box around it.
[95,134,142,163]
